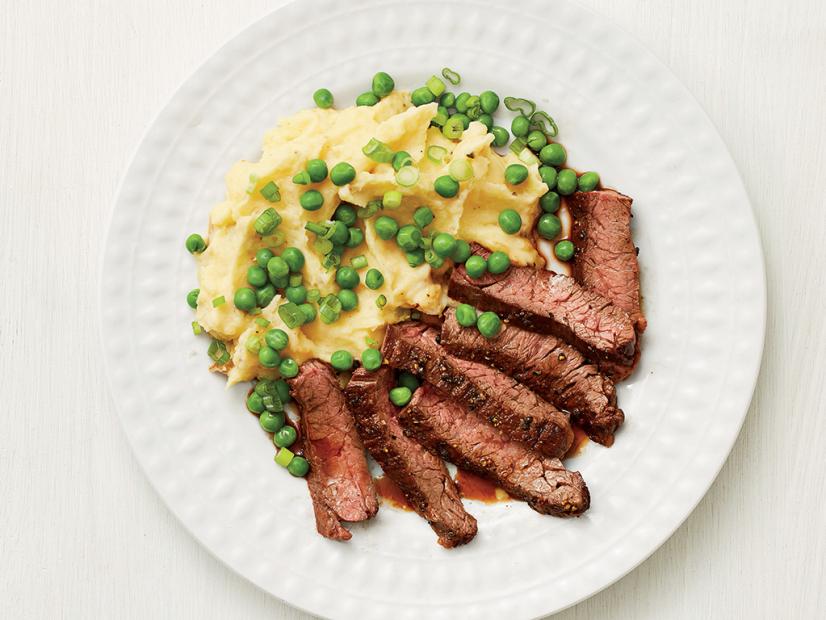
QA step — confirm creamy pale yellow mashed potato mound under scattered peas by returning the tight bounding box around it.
[197,92,547,384]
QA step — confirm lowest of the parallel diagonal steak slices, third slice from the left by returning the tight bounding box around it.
[399,384,591,517]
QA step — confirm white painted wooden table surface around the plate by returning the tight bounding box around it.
[0,0,826,620]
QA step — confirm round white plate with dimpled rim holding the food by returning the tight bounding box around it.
[101,0,765,620]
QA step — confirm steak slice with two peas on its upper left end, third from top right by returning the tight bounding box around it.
[441,309,625,446]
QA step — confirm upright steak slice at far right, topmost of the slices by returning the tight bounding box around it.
[566,190,647,334]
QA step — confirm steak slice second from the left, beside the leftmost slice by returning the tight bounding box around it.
[344,366,476,548]
